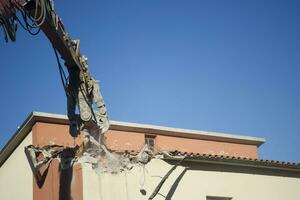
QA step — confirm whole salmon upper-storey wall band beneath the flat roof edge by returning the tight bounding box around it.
[32,122,258,158]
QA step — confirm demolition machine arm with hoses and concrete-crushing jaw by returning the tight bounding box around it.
[0,0,109,137]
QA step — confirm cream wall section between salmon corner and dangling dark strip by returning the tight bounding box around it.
[82,159,184,200]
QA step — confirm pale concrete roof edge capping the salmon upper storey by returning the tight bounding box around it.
[0,112,265,167]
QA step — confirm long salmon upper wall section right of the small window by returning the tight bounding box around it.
[155,135,258,158]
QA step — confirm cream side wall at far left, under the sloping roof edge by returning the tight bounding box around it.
[0,133,33,200]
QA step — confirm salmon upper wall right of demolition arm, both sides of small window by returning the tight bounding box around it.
[106,130,258,158]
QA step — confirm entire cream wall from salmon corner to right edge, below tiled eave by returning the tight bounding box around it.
[83,159,300,200]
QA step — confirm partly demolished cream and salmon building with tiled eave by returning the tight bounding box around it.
[0,112,300,200]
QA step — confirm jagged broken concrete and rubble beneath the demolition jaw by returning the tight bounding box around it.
[25,132,158,181]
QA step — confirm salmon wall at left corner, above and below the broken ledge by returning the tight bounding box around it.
[32,122,83,200]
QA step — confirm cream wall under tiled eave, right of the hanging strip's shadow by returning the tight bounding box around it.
[173,162,300,200]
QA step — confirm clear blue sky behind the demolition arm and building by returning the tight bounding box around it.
[0,0,300,162]
